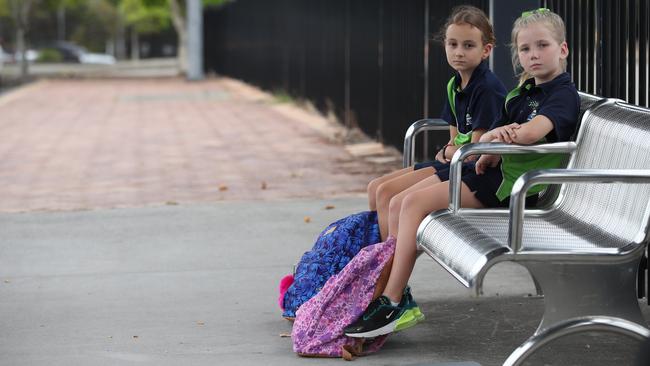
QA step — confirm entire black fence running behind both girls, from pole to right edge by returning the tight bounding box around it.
[204,0,650,149]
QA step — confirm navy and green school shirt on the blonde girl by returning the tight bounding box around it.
[493,72,580,201]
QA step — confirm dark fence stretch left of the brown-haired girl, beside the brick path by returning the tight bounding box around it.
[204,0,489,155]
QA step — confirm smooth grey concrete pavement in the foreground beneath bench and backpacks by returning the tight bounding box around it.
[0,198,650,366]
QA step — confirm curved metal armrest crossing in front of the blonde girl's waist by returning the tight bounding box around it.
[449,142,577,212]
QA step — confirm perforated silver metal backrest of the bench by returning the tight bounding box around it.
[556,100,650,243]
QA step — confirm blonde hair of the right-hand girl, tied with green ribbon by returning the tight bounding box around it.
[510,8,567,85]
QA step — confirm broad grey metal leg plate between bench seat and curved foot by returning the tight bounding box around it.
[520,258,646,334]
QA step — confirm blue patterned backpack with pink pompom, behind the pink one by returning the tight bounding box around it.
[279,211,381,319]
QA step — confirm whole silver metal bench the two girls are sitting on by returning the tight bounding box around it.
[417,100,650,365]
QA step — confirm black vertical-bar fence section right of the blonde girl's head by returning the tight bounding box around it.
[544,0,650,107]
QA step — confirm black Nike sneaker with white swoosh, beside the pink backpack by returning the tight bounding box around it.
[344,295,404,338]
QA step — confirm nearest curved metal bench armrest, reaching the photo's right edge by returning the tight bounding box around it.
[508,169,650,253]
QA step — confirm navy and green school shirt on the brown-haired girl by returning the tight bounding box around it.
[441,61,507,145]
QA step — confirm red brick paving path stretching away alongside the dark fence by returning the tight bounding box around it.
[0,79,396,212]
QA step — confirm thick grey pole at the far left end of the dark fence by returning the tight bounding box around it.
[187,0,203,80]
